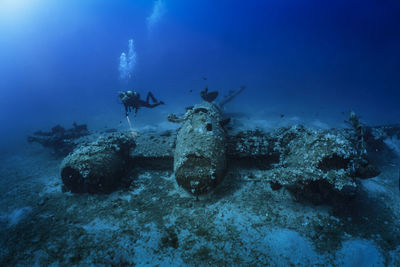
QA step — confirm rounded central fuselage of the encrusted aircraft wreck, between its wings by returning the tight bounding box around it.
[168,86,241,195]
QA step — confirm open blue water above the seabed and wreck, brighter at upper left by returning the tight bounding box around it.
[0,0,400,149]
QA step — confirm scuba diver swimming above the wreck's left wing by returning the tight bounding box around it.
[119,91,165,117]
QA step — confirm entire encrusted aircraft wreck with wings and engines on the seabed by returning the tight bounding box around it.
[52,87,384,203]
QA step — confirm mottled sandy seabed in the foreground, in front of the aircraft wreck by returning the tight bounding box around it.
[0,130,400,266]
